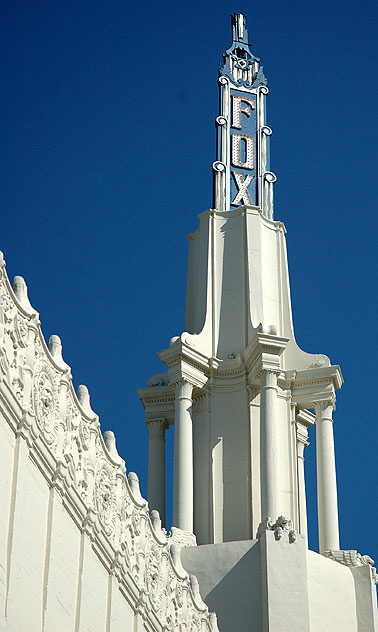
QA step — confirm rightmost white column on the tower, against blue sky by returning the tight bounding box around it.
[314,400,340,553]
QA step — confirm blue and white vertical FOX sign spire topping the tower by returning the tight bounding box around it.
[213,13,276,219]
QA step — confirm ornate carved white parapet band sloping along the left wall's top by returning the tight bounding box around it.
[0,255,218,632]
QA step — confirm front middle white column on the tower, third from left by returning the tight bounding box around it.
[260,369,279,520]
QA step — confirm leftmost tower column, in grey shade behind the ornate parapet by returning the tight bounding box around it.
[146,418,168,526]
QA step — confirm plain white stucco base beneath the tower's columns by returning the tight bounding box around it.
[181,531,377,632]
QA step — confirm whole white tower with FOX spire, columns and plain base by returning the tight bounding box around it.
[138,14,378,632]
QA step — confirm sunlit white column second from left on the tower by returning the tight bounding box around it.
[173,380,193,533]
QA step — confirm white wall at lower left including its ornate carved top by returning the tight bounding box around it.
[0,256,217,632]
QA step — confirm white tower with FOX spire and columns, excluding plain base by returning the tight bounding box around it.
[138,14,342,552]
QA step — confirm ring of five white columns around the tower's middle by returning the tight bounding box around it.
[146,376,339,552]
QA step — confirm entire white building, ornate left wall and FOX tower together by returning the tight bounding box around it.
[0,9,378,632]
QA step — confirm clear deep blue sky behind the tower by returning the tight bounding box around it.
[0,0,378,561]
